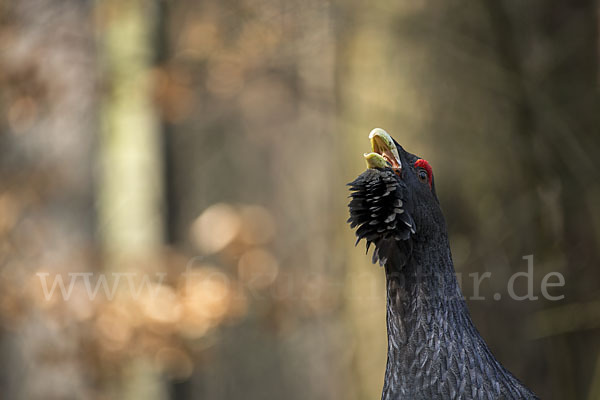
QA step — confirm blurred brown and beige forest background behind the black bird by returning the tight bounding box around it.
[0,0,600,400]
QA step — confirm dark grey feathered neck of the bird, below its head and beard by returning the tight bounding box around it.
[383,234,535,399]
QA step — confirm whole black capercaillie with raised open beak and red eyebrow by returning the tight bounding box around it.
[348,129,537,400]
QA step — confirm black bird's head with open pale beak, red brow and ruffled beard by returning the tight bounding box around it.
[348,128,445,266]
